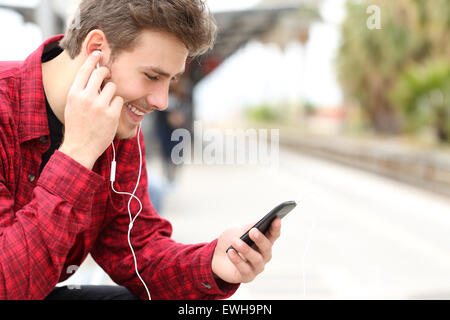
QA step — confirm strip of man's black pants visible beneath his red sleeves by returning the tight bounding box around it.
[45,286,139,300]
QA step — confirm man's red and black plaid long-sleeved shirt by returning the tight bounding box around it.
[0,35,238,299]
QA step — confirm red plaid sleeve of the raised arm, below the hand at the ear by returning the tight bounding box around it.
[0,151,102,300]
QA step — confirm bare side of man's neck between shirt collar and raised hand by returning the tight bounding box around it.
[42,51,81,124]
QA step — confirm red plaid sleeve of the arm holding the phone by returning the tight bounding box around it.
[91,132,239,300]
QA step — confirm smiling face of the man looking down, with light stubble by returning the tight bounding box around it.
[103,30,189,139]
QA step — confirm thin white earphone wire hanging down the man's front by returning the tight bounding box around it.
[110,126,152,300]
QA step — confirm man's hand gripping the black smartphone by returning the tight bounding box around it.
[212,218,281,283]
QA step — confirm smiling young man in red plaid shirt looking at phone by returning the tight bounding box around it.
[0,0,281,299]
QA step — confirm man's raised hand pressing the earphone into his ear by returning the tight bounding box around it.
[59,52,124,169]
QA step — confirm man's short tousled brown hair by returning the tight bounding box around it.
[60,0,217,59]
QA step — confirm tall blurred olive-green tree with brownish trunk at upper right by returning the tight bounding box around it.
[337,0,429,134]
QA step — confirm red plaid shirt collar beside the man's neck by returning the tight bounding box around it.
[19,35,64,143]
